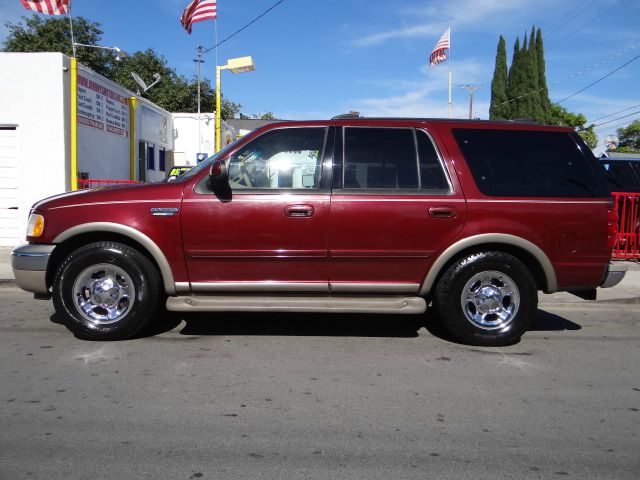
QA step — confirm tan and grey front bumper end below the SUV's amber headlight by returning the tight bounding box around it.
[11,244,56,295]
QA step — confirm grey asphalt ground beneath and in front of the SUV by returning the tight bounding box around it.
[0,286,640,479]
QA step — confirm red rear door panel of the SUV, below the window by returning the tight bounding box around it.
[329,194,466,284]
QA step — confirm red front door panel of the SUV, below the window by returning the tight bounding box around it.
[182,190,329,286]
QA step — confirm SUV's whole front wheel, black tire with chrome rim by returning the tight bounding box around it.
[53,242,162,340]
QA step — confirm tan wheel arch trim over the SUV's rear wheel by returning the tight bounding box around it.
[420,234,557,296]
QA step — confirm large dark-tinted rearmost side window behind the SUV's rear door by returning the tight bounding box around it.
[453,128,607,197]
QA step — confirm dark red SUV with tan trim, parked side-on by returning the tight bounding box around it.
[12,118,624,345]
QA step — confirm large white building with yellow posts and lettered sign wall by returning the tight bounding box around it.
[0,53,173,246]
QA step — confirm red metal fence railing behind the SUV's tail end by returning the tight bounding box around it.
[612,192,640,261]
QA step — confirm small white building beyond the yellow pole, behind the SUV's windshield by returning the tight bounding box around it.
[171,113,237,166]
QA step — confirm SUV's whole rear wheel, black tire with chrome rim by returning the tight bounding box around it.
[433,251,538,346]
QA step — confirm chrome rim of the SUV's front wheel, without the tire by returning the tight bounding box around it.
[73,263,136,325]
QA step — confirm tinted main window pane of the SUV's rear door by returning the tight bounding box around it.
[342,127,419,190]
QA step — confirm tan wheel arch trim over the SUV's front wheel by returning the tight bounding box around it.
[47,224,176,295]
